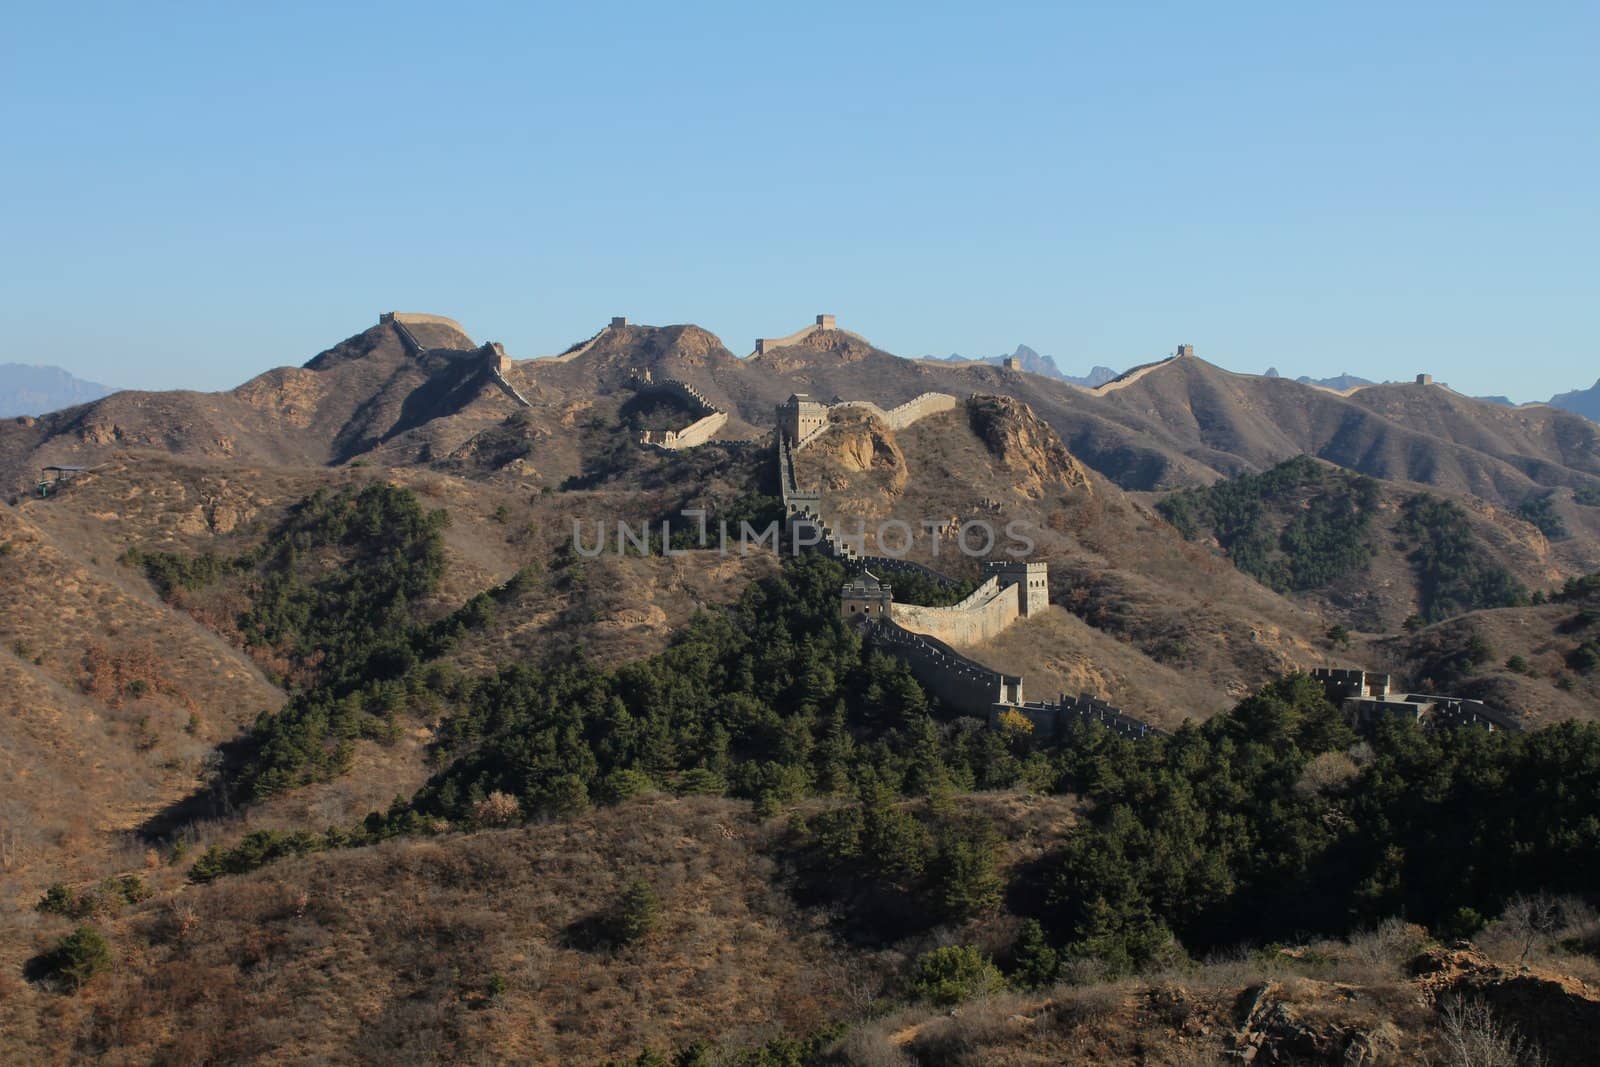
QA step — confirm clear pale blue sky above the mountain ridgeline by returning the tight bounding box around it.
[0,0,1600,400]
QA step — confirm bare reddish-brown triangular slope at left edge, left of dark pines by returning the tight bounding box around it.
[0,501,283,905]
